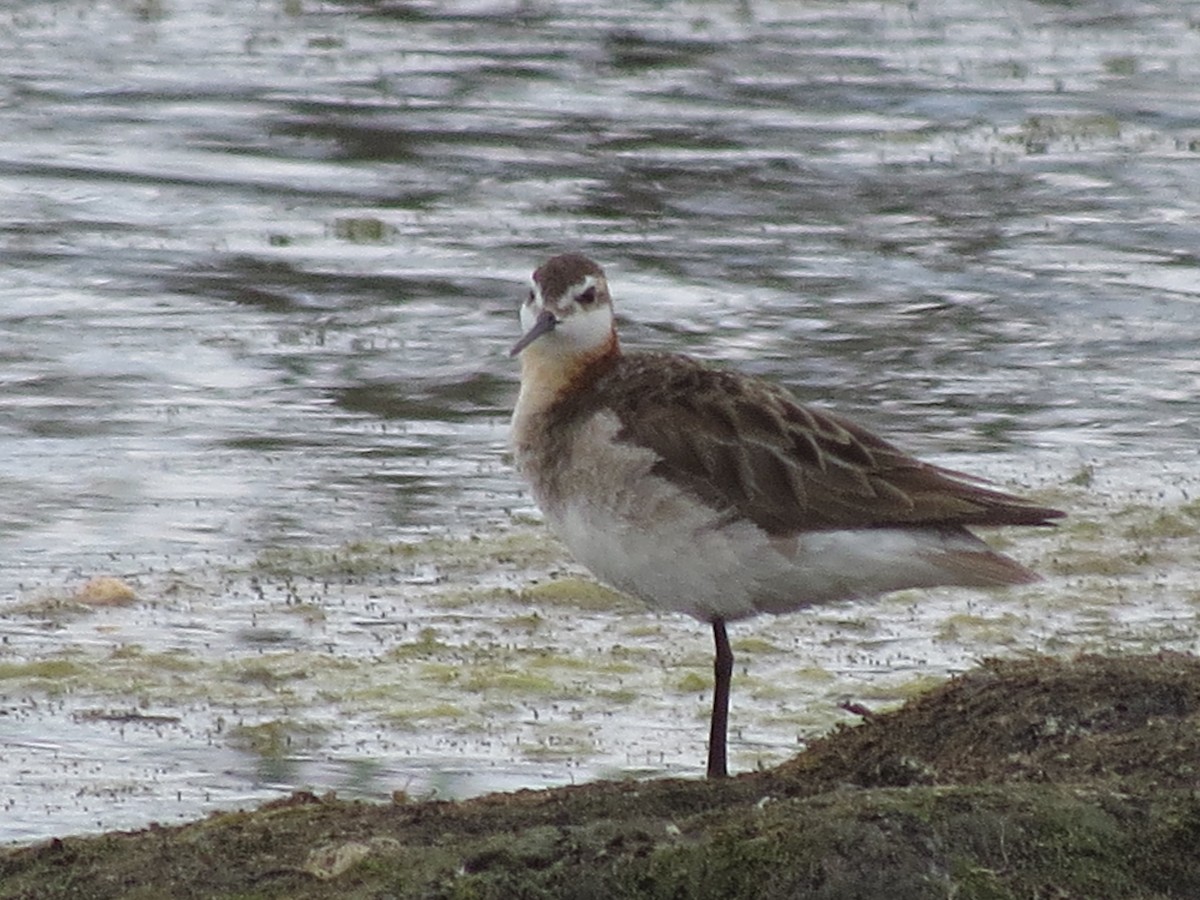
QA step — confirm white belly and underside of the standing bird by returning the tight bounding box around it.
[520,415,1024,622]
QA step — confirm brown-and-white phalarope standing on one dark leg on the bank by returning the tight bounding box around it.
[512,253,1063,778]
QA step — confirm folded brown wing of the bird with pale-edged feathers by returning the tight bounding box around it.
[593,354,1063,534]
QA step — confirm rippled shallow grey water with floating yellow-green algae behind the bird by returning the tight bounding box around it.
[0,0,1200,839]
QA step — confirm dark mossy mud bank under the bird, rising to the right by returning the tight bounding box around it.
[0,653,1200,900]
